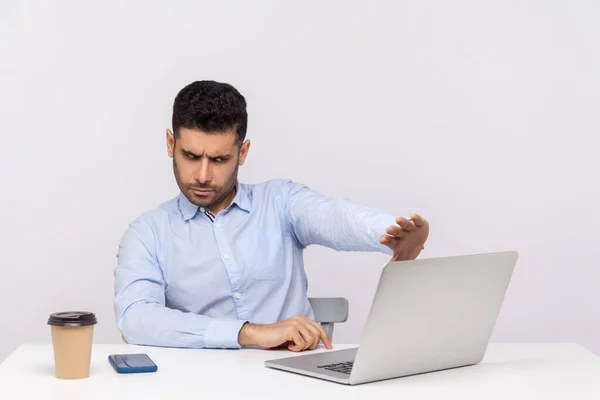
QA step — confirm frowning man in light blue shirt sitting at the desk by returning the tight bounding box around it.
[115,81,429,351]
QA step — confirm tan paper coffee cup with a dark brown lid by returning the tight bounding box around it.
[48,311,97,379]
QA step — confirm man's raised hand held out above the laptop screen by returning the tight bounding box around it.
[379,214,429,261]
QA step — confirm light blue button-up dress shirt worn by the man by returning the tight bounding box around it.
[114,180,395,348]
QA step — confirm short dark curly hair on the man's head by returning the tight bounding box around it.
[173,81,248,144]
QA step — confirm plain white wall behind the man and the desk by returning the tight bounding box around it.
[0,0,600,360]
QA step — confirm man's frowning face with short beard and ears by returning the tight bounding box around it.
[167,128,250,214]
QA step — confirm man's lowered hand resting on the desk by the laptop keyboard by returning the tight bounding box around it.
[238,315,332,351]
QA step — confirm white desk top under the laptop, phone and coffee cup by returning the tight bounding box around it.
[0,343,600,400]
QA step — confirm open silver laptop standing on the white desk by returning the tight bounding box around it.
[265,251,518,385]
